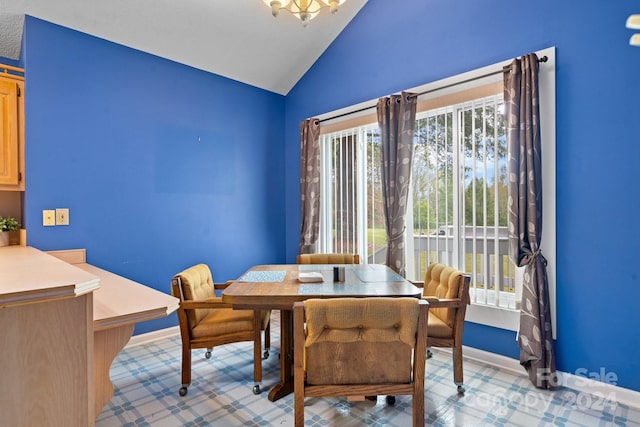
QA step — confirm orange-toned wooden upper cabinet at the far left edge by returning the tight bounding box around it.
[0,65,24,191]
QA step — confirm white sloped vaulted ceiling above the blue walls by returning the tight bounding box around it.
[0,0,367,95]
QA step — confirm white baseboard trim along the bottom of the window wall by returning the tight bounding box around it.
[432,346,640,409]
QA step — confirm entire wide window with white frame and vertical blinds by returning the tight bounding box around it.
[319,48,555,333]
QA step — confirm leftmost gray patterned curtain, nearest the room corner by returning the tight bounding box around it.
[298,119,320,254]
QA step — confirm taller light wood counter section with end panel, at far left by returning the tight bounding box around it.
[0,246,99,427]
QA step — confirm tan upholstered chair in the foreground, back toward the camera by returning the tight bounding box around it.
[293,297,429,427]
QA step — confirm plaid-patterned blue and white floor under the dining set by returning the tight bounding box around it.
[96,312,640,427]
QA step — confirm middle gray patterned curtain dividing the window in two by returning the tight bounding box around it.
[377,92,417,276]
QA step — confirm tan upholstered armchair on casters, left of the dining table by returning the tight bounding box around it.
[171,264,271,396]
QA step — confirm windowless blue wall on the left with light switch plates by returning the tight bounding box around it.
[23,17,284,333]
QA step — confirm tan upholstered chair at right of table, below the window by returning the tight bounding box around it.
[416,263,471,394]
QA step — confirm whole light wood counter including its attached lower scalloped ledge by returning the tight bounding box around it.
[0,246,178,427]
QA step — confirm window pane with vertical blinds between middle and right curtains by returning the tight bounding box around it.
[407,93,516,308]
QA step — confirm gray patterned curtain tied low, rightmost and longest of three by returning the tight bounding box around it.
[504,53,557,389]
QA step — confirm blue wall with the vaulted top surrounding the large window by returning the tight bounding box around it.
[285,0,640,391]
